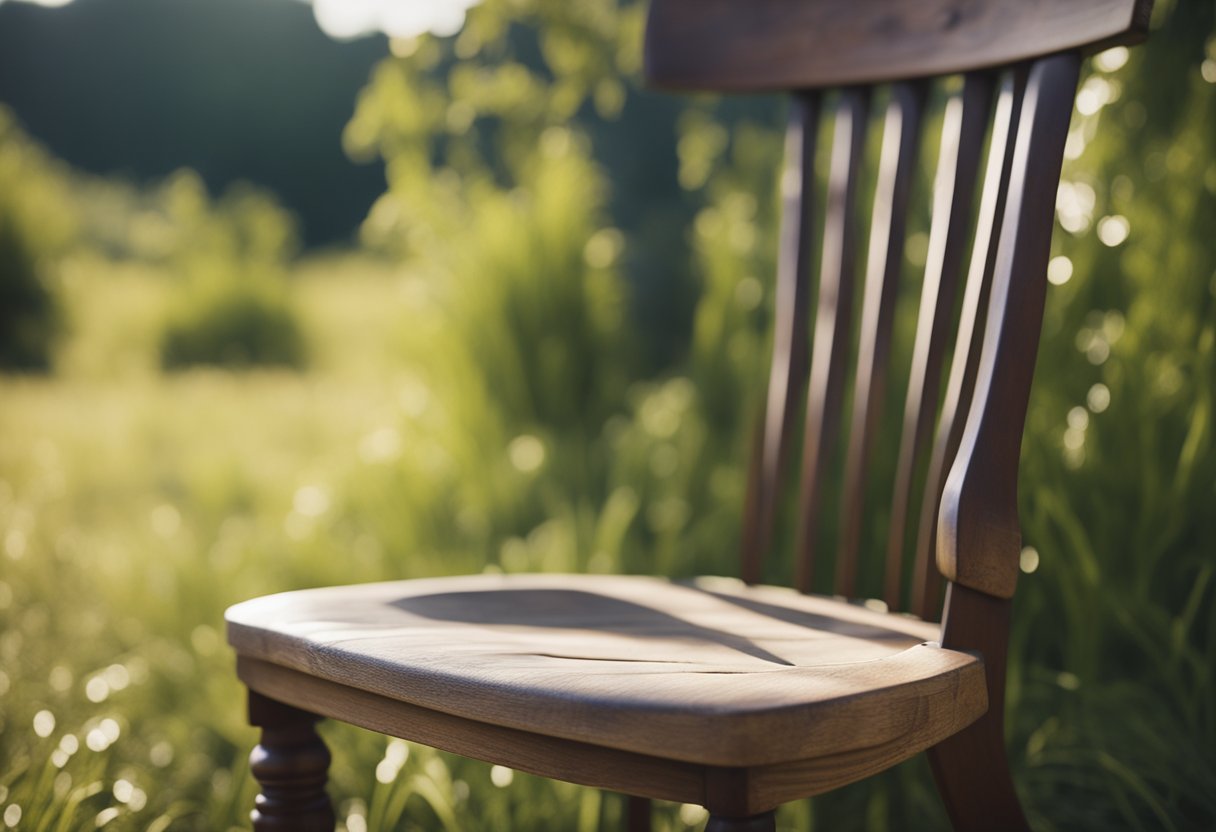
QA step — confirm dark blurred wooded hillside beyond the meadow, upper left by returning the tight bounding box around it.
[0,0,388,246]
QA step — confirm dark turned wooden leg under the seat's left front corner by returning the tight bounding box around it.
[249,691,334,832]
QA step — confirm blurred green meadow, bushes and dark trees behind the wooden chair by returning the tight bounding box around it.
[0,0,1216,832]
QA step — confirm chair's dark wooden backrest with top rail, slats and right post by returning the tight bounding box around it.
[646,0,1152,618]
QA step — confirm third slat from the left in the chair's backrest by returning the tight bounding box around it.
[835,81,928,597]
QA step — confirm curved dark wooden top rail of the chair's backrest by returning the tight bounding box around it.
[646,0,1152,91]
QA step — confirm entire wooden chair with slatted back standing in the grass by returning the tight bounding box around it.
[227,0,1149,832]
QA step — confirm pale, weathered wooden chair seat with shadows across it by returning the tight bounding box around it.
[227,575,987,766]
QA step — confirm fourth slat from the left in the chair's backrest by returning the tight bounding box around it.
[883,73,993,609]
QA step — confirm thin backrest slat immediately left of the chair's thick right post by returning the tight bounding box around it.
[911,69,1026,619]
